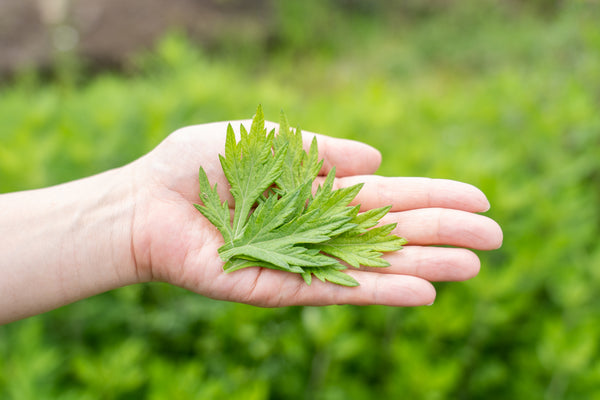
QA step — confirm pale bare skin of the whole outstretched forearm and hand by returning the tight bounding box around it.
[0,121,502,324]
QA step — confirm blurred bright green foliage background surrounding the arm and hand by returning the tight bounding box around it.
[0,0,600,400]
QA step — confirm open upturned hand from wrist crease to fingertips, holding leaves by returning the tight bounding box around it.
[129,121,502,307]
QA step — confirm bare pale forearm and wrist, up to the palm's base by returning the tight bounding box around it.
[0,169,137,324]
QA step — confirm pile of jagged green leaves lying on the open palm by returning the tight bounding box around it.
[194,106,406,286]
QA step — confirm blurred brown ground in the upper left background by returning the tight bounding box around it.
[0,0,268,75]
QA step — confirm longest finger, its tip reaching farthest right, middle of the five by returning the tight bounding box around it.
[381,208,502,250]
